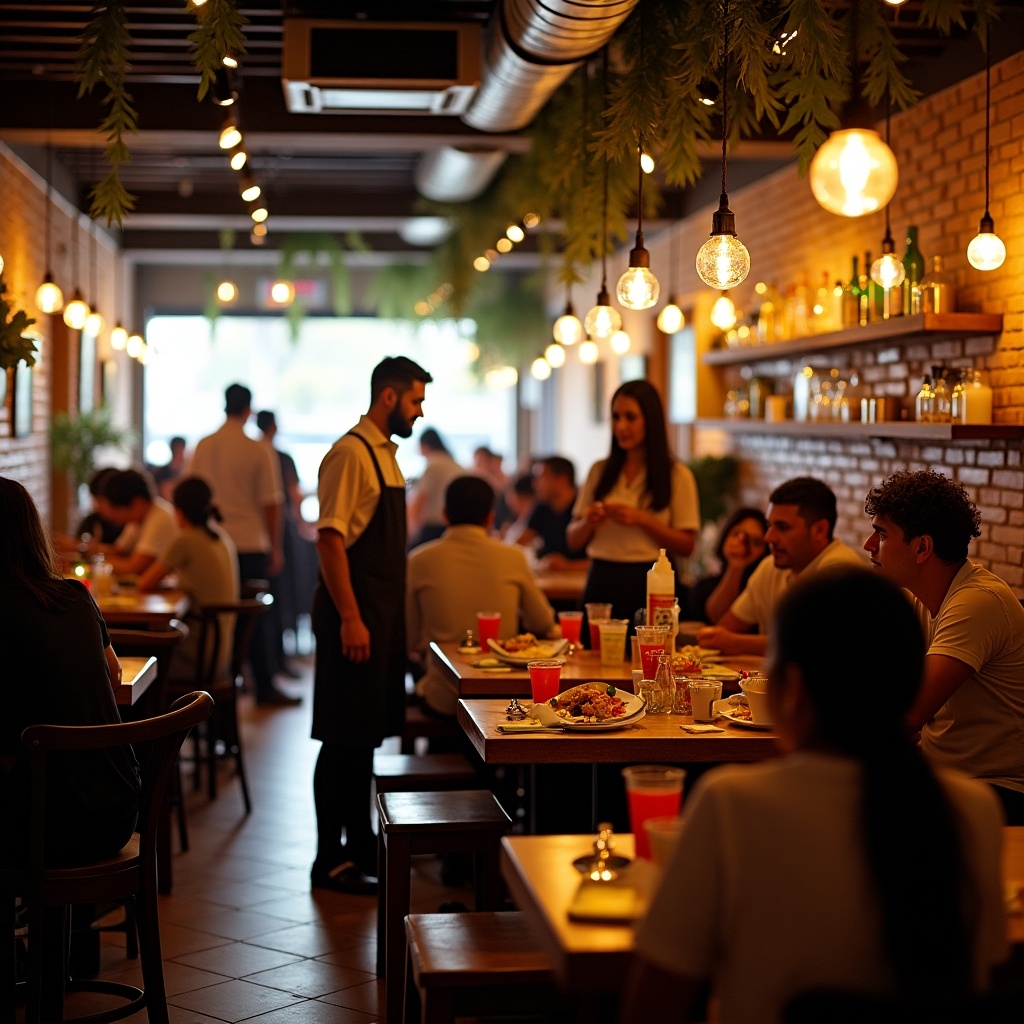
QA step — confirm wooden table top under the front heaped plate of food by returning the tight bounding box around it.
[458,698,778,765]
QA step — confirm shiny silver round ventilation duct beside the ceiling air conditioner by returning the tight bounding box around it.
[416,0,638,203]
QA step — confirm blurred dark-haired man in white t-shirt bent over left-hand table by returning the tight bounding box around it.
[98,469,178,575]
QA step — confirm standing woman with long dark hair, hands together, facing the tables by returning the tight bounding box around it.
[566,381,700,622]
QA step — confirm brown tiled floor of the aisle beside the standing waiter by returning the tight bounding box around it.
[48,665,472,1024]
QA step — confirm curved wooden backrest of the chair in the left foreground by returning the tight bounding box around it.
[22,691,213,872]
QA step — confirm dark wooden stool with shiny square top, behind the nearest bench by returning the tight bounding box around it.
[377,790,512,1024]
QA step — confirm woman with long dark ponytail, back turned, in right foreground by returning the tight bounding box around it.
[625,568,1006,1024]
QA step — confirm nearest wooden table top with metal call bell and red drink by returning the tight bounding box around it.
[502,826,1024,992]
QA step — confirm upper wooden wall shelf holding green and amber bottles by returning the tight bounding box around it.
[701,313,1002,367]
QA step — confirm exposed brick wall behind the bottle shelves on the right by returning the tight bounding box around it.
[652,54,1024,597]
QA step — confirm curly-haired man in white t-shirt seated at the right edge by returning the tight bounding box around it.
[864,470,1024,825]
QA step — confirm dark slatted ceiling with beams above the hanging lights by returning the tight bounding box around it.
[0,0,1022,266]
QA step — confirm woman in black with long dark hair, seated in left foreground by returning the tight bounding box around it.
[0,477,139,864]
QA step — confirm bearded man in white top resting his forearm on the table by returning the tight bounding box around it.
[696,476,864,654]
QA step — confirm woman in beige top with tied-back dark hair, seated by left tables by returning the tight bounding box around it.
[138,476,239,684]
